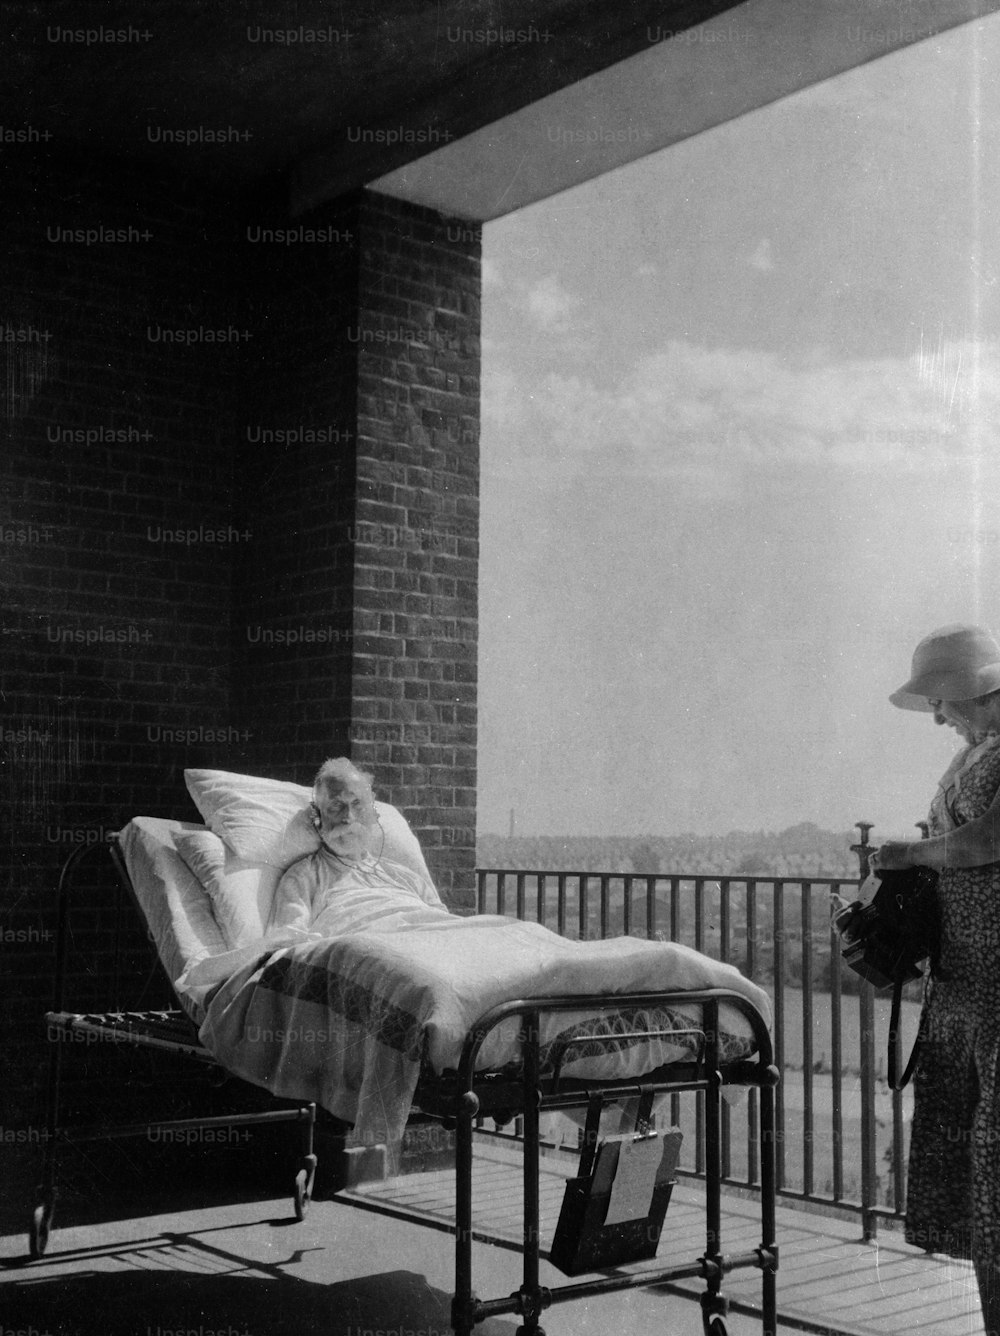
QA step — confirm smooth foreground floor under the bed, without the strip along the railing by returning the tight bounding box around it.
[0,1198,789,1336]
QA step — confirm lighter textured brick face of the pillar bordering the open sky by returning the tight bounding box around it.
[351,194,481,907]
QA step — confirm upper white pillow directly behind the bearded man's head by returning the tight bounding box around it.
[184,770,431,882]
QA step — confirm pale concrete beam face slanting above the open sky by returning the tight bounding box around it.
[363,0,1000,222]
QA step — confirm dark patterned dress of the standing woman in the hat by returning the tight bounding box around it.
[907,737,1000,1264]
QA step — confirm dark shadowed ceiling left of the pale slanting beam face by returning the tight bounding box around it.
[0,0,736,198]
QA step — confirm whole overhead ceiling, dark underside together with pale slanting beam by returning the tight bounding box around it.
[0,0,1000,222]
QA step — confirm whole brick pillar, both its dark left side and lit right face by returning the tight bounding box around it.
[235,192,481,907]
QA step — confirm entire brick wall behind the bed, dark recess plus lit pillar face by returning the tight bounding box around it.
[0,148,479,1191]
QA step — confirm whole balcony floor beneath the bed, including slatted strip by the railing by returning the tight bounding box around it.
[0,1138,983,1336]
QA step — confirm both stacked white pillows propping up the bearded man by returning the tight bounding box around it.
[175,770,430,949]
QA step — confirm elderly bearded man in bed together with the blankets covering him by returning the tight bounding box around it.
[178,759,770,1162]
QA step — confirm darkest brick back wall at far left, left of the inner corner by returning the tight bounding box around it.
[0,148,236,1120]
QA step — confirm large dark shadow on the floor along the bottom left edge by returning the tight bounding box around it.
[0,1271,515,1336]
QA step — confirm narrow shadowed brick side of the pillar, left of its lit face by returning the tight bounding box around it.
[234,188,358,783]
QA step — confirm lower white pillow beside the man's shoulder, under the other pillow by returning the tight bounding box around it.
[174,831,282,950]
